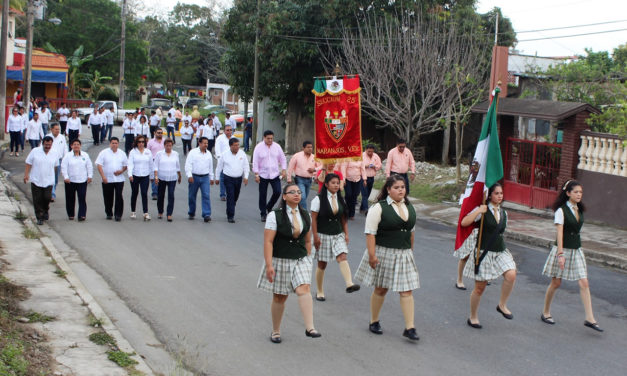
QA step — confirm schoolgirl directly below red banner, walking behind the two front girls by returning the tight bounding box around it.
[311,174,359,301]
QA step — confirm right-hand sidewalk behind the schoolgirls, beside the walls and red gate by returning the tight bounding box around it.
[410,197,627,271]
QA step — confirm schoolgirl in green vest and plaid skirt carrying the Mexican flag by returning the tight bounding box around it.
[462,183,516,329]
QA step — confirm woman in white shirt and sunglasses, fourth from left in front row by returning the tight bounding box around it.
[128,135,154,221]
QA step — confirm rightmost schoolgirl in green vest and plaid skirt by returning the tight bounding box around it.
[540,180,603,332]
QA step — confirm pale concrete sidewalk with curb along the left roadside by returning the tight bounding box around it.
[0,170,153,376]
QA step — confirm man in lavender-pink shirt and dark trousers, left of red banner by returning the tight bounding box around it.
[253,130,287,222]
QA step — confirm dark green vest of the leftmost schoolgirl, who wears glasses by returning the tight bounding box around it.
[272,209,310,259]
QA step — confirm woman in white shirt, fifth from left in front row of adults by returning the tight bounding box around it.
[154,138,181,222]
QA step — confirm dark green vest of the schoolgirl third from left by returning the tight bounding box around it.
[375,200,416,249]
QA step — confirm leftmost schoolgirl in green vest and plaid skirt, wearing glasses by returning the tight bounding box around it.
[257,184,321,343]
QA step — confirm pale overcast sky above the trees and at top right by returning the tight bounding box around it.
[143,0,627,56]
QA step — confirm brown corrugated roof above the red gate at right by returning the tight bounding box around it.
[472,98,600,121]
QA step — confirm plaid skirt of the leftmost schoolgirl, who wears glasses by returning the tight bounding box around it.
[257,256,313,295]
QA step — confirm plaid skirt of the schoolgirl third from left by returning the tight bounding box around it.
[355,245,420,291]
